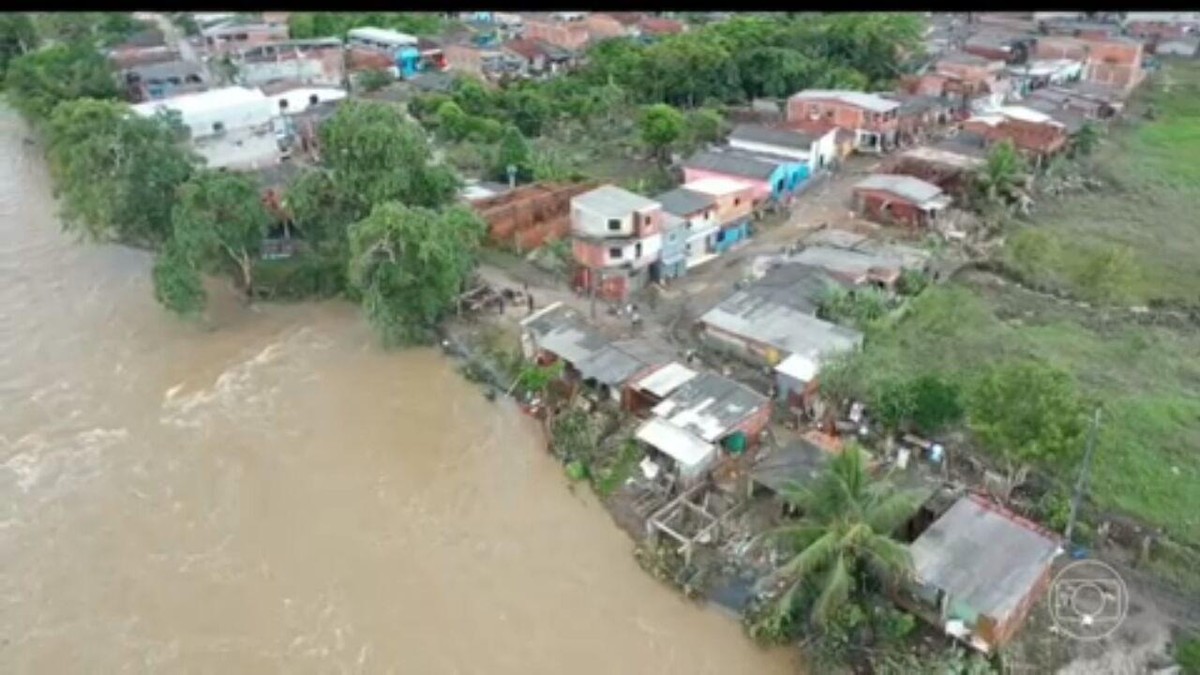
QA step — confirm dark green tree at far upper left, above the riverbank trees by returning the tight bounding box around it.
[5,43,118,124]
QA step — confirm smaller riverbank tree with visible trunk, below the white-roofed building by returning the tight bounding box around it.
[172,171,271,297]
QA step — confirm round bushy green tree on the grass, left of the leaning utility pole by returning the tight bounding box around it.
[966,362,1085,466]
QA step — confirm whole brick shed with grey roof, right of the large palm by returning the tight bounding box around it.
[898,495,1062,653]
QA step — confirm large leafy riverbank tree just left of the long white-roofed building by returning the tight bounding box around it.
[46,98,196,249]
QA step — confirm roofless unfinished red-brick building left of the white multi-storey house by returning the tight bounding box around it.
[472,183,596,252]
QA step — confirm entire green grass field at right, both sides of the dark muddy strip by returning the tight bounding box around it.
[863,60,1200,550]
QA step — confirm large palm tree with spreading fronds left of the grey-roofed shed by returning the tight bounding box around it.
[760,444,918,626]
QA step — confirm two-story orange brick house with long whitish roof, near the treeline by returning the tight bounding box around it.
[787,89,900,154]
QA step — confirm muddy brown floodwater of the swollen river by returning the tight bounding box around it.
[0,112,796,675]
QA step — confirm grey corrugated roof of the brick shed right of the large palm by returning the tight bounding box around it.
[910,496,1060,621]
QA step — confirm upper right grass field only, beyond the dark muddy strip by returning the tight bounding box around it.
[1010,62,1200,303]
